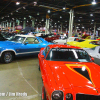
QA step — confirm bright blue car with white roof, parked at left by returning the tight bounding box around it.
[0,35,53,63]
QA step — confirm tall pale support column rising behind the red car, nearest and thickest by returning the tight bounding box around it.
[68,9,74,37]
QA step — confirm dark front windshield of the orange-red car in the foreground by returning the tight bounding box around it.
[46,48,91,62]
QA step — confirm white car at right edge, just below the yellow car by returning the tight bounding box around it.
[84,46,100,59]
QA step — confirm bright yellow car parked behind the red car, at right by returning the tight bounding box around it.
[67,39,100,48]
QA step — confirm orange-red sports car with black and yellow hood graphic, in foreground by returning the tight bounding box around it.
[38,45,100,100]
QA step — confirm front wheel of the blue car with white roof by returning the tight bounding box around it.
[1,52,14,63]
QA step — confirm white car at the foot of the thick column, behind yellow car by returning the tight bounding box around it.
[53,37,79,44]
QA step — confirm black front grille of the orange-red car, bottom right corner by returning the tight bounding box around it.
[76,94,100,100]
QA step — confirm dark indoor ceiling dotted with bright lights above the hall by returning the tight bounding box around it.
[0,0,100,29]
